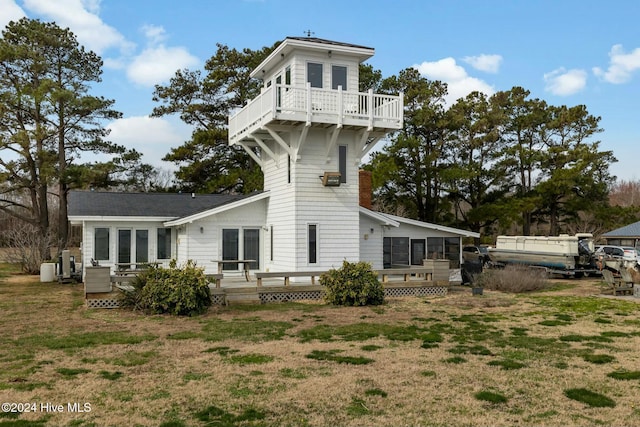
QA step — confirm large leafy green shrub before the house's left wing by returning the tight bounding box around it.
[121,260,211,316]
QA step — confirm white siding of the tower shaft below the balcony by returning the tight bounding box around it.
[263,125,360,271]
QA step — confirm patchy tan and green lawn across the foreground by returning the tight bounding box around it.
[0,267,640,427]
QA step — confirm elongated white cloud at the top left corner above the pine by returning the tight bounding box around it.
[24,0,133,55]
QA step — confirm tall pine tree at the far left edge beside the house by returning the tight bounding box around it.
[0,18,125,259]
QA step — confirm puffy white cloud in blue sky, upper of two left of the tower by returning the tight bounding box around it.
[127,45,200,87]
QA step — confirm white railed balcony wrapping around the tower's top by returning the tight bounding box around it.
[229,85,403,144]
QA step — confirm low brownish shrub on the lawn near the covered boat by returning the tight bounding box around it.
[475,265,549,293]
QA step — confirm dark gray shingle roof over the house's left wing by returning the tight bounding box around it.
[69,191,249,218]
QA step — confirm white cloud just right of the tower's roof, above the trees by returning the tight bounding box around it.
[413,57,495,105]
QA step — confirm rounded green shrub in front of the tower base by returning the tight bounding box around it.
[320,261,384,306]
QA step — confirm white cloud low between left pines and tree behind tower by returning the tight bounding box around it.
[107,116,193,168]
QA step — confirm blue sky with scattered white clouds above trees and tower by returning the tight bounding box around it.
[0,0,640,180]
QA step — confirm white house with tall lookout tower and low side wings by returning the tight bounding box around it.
[69,37,478,273]
